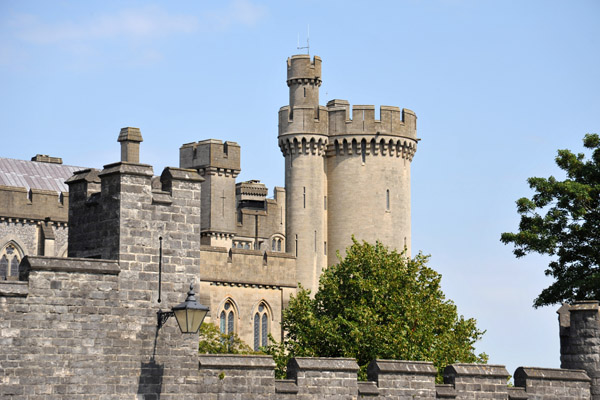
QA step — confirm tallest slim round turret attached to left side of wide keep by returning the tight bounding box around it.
[279,55,328,293]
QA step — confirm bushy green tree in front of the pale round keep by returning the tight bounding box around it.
[269,238,487,379]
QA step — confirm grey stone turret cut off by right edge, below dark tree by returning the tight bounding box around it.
[558,300,600,400]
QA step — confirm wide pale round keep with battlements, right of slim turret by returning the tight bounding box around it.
[326,100,417,265]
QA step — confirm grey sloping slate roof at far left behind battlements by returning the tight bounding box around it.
[0,157,85,192]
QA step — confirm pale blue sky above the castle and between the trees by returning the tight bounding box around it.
[0,0,600,373]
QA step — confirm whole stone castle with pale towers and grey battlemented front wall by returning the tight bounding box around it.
[0,55,600,400]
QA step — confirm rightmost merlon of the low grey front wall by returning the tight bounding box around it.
[513,367,590,400]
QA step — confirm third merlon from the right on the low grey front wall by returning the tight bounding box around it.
[367,360,437,400]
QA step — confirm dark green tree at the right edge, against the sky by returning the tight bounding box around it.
[500,134,600,308]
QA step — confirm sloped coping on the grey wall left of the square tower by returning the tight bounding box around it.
[21,256,121,275]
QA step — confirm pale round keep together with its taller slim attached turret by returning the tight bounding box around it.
[279,55,418,292]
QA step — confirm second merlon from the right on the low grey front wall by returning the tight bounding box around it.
[444,364,509,400]
